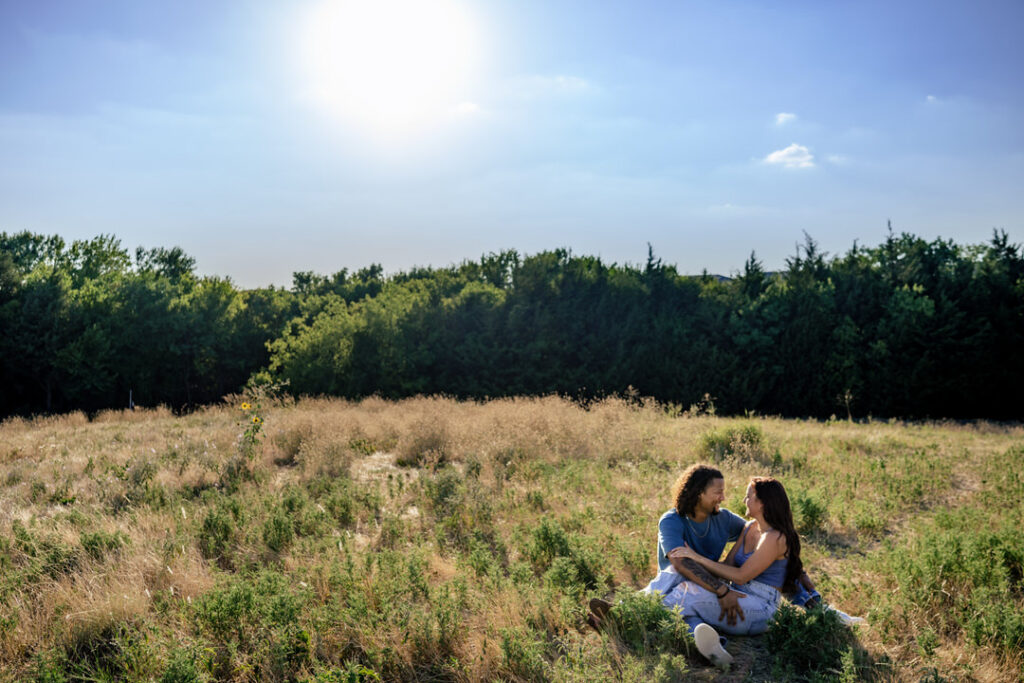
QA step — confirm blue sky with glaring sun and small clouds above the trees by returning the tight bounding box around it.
[0,0,1024,287]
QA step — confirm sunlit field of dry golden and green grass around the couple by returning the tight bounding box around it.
[0,396,1024,682]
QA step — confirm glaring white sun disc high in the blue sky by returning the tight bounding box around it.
[300,0,479,136]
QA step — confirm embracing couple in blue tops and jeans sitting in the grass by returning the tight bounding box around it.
[590,465,852,666]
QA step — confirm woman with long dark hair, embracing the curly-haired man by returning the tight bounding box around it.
[669,477,804,664]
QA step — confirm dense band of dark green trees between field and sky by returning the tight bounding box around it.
[0,230,1024,420]
